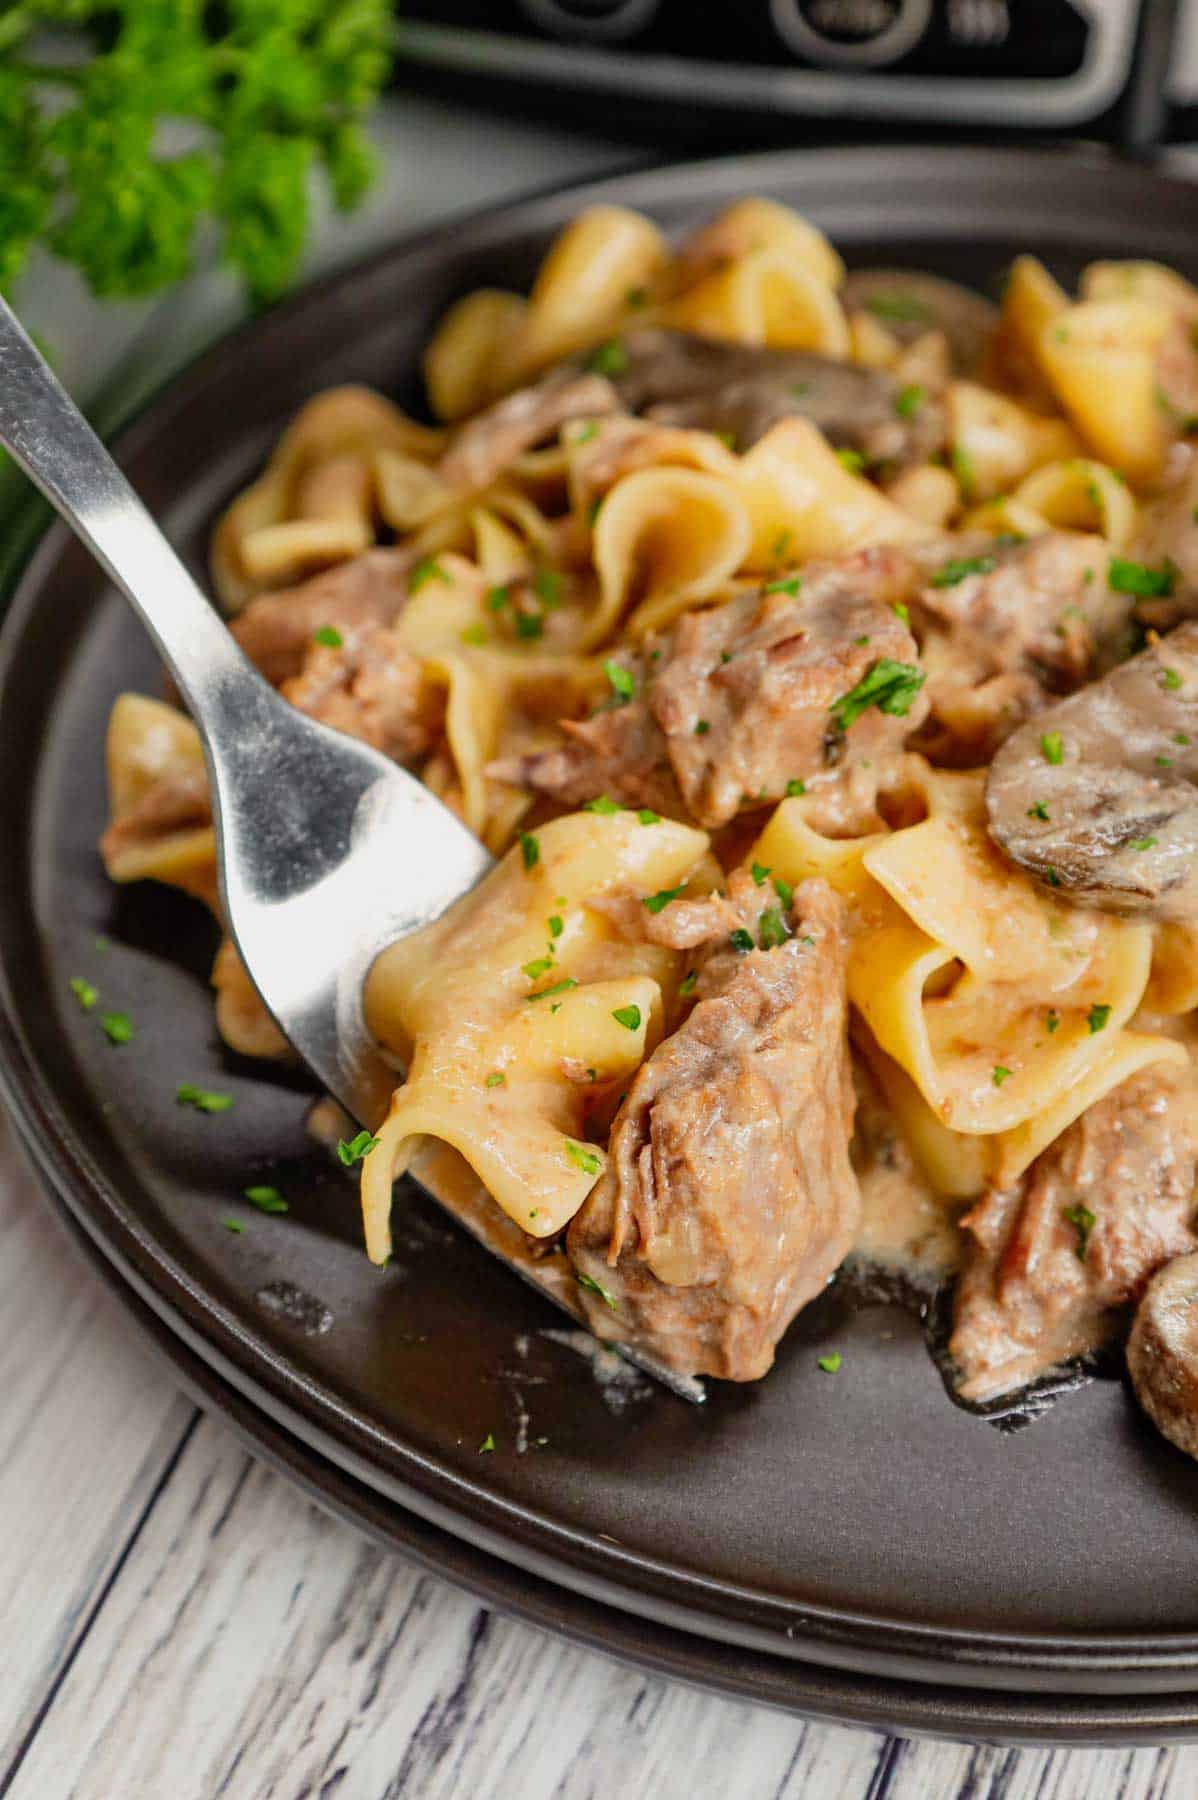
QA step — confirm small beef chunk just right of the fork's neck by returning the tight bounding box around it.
[281,625,444,763]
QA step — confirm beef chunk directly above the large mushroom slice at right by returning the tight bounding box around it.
[912,531,1128,769]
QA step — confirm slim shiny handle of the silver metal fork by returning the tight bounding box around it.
[0,299,248,720]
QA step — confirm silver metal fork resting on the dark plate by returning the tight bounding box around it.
[0,301,703,1400]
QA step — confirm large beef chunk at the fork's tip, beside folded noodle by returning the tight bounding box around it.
[567,882,860,1381]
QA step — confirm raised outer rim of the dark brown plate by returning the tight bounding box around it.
[0,144,1198,1694]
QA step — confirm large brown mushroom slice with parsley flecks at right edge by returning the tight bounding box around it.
[986,625,1198,920]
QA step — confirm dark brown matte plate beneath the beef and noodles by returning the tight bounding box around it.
[0,148,1198,1728]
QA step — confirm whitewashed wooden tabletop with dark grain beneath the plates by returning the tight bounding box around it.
[0,87,1198,1800]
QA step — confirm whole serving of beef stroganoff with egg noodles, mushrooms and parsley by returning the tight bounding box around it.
[103,189,1198,1449]
